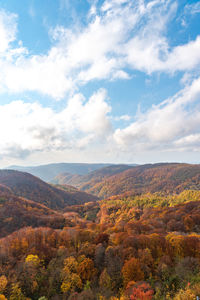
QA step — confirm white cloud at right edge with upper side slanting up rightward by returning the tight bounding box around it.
[114,78,200,152]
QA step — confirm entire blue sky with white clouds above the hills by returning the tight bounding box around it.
[0,0,200,168]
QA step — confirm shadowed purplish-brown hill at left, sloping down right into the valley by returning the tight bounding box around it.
[0,170,97,209]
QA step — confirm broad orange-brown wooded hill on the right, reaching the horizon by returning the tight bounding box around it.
[81,163,200,198]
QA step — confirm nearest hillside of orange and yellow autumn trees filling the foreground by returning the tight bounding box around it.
[0,191,200,300]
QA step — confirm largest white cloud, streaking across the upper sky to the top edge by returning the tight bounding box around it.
[0,0,200,99]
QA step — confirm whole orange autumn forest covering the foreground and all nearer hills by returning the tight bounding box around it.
[0,164,200,300]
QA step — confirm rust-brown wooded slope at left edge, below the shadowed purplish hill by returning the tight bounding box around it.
[0,186,67,237]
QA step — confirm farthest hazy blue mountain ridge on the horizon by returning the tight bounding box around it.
[8,163,110,182]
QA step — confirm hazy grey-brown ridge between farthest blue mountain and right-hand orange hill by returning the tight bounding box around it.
[52,165,133,190]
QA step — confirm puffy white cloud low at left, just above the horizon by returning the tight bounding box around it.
[0,90,112,158]
